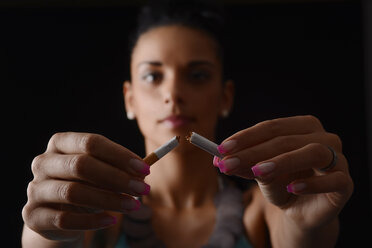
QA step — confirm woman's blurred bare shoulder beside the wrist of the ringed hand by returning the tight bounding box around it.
[243,185,270,247]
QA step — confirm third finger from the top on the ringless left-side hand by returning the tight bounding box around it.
[27,180,140,213]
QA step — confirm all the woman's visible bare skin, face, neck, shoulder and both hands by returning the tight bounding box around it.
[22,25,353,247]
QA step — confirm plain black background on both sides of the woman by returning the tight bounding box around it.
[0,1,371,247]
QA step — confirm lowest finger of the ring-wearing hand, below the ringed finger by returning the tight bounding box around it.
[287,171,353,200]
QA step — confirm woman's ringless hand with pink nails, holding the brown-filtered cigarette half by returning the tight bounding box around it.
[22,132,150,241]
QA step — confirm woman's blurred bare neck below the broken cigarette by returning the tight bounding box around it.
[144,140,218,209]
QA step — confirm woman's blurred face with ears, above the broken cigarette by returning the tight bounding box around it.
[124,25,233,145]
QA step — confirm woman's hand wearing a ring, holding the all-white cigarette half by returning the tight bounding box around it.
[214,116,353,229]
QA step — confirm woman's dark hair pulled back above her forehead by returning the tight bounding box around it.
[129,0,230,79]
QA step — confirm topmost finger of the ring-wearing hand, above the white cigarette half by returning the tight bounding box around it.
[218,115,324,154]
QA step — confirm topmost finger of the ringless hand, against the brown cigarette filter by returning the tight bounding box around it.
[47,132,148,174]
